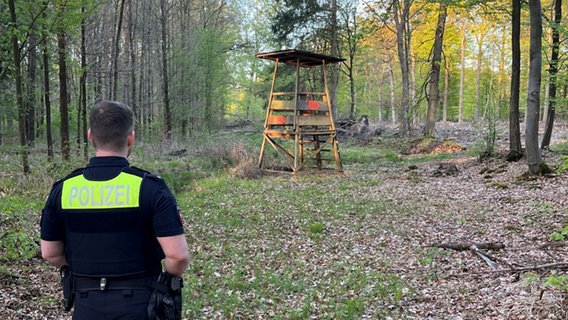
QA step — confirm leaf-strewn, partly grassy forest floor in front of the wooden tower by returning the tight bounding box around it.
[0,121,568,319]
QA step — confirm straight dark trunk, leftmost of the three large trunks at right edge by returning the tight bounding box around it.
[507,0,523,161]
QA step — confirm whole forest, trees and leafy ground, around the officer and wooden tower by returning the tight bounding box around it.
[0,0,568,319]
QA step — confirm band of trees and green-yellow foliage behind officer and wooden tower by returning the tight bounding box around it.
[0,0,568,172]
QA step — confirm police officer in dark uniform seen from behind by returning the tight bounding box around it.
[41,101,189,320]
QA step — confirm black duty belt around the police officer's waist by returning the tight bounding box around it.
[74,277,156,291]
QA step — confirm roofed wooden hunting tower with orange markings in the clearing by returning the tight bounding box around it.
[256,49,345,173]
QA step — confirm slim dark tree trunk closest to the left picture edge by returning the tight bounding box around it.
[8,0,31,174]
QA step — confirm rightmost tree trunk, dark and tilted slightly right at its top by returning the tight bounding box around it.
[540,0,562,149]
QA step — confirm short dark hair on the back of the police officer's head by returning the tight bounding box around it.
[89,100,134,151]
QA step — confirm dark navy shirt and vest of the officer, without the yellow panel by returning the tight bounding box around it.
[41,157,184,276]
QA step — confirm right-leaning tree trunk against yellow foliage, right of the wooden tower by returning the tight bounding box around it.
[424,4,447,137]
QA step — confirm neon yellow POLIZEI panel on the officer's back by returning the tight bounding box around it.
[61,172,142,209]
